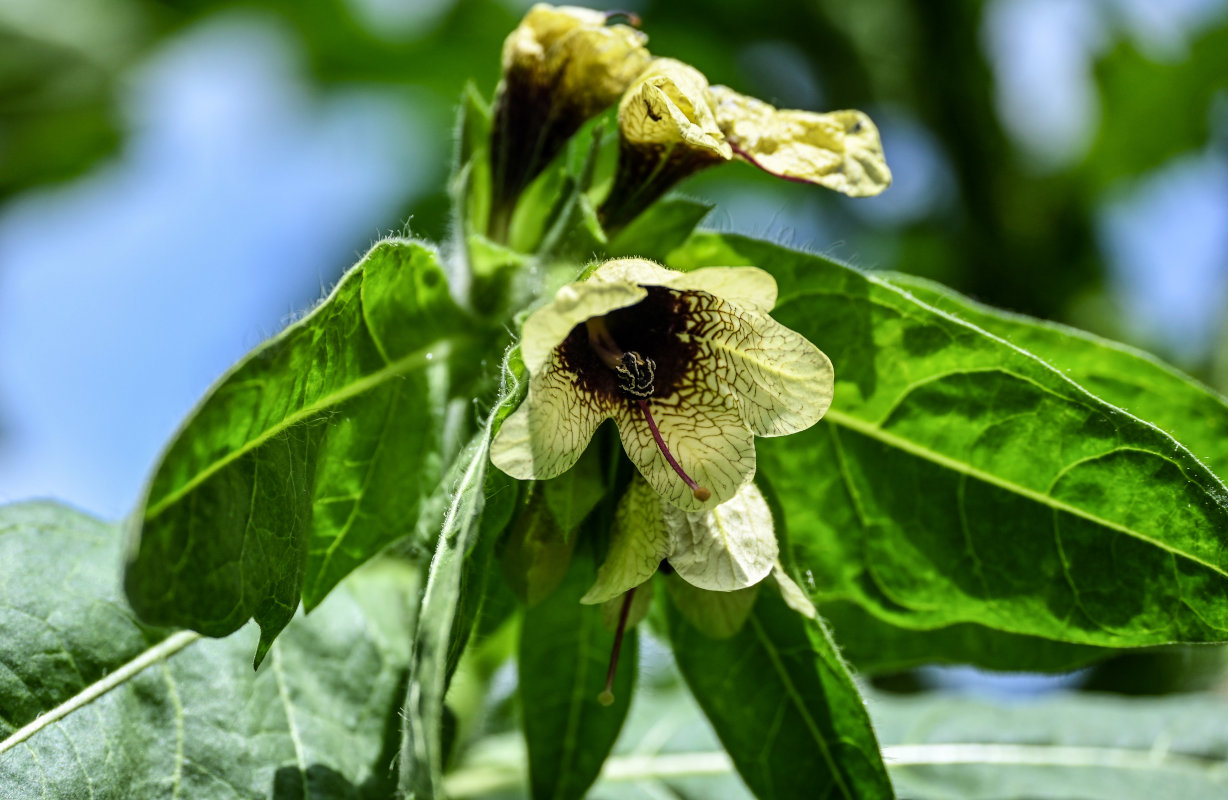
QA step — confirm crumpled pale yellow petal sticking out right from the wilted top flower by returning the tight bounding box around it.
[709,86,892,197]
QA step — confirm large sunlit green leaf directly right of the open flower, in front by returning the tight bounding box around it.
[670,233,1228,646]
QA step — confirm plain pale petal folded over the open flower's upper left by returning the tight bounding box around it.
[521,280,648,375]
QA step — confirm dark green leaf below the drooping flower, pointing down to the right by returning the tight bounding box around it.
[669,587,894,800]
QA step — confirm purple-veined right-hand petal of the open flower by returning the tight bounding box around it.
[686,292,835,436]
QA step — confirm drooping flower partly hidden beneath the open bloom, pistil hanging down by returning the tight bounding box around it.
[580,478,817,702]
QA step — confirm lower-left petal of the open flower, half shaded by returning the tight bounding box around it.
[490,359,612,480]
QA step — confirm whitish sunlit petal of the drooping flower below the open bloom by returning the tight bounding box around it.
[662,483,780,591]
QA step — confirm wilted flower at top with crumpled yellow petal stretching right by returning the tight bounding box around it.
[598,59,892,232]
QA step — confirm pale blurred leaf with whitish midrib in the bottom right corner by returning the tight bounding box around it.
[871,694,1228,800]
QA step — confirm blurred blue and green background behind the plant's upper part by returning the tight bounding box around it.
[0,0,1228,517]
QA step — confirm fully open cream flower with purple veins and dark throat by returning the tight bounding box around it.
[490,258,834,511]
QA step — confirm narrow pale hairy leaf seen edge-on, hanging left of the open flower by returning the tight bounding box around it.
[399,364,523,799]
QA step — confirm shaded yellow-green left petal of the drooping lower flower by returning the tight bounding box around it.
[580,478,669,603]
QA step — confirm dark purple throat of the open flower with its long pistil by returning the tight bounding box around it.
[560,286,712,503]
